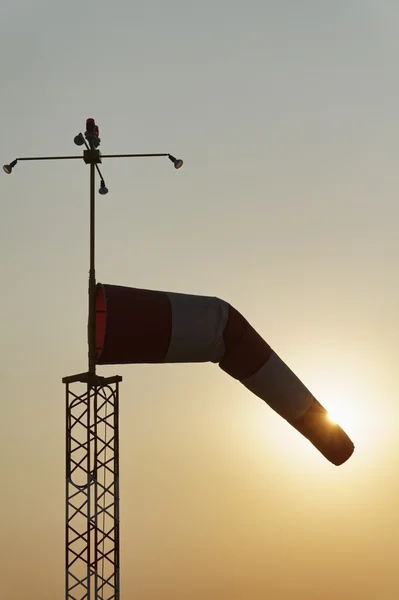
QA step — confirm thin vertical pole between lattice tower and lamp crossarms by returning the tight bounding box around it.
[88,163,96,375]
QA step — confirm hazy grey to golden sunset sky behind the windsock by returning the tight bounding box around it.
[0,0,399,600]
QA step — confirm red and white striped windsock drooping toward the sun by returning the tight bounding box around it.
[96,284,354,465]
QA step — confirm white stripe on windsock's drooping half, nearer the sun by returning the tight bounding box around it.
[241,352,315,421]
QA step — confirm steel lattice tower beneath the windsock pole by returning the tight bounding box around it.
[63,373,122,600]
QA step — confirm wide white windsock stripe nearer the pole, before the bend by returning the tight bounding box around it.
[165,292,229,363]
